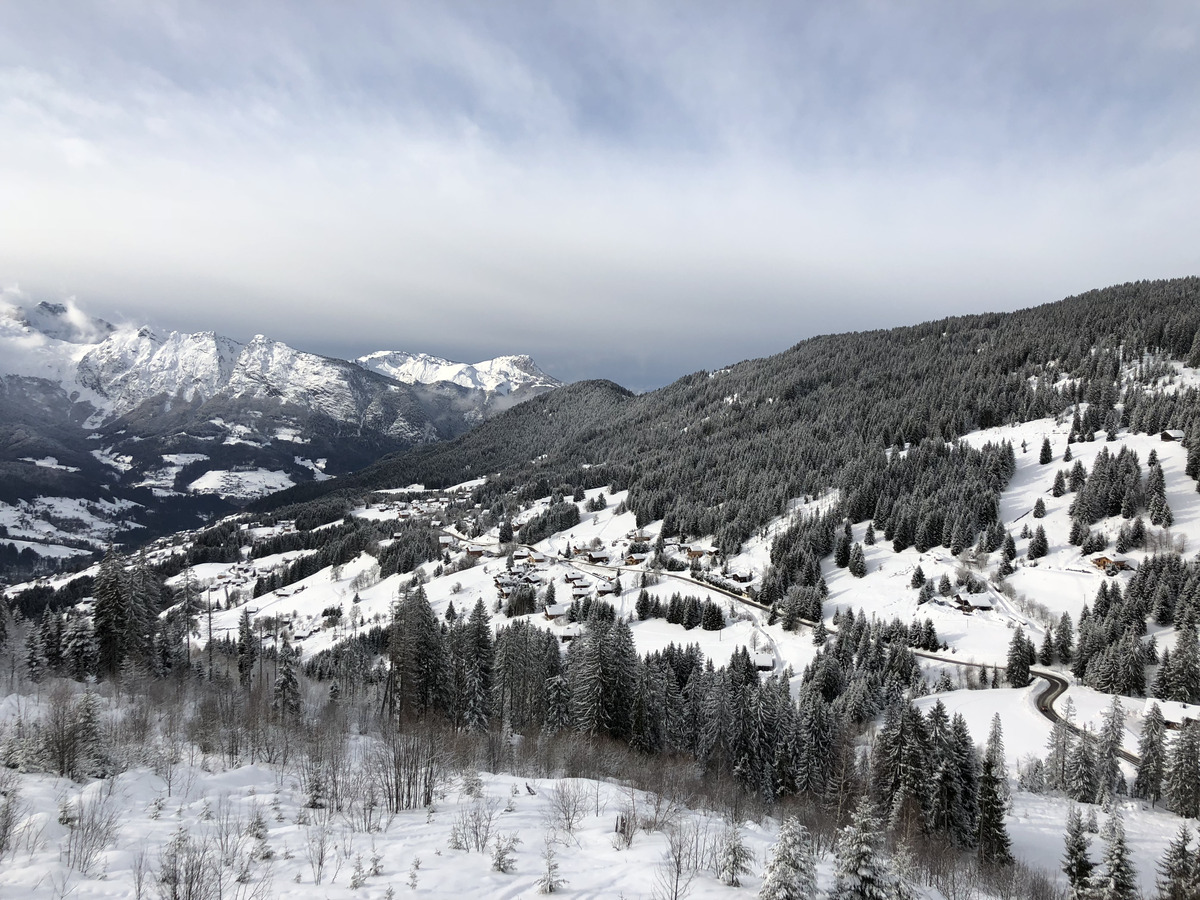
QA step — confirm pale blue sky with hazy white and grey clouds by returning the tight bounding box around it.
[0,0,1200,390]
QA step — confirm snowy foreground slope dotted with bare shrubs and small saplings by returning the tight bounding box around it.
[0,739,806,900]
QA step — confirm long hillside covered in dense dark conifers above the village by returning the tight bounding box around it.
[260,277,1200,552]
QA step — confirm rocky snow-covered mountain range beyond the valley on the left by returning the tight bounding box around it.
[0,290,558,564]
